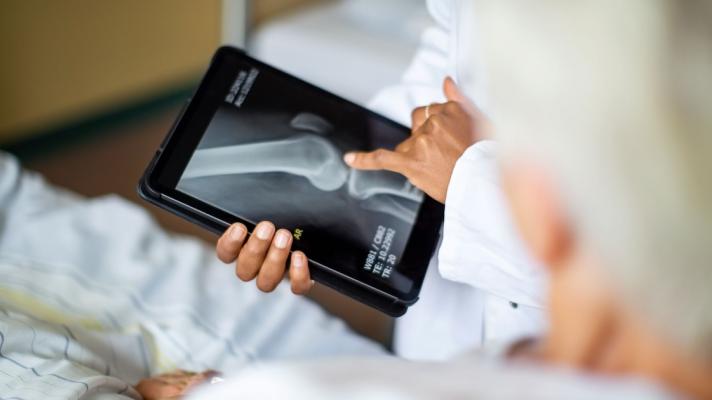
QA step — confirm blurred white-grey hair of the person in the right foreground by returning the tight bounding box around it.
[476,0,712,360]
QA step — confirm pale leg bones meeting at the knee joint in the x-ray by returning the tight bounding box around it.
[183,134,422,222]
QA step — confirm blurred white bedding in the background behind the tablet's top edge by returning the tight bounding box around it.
[247,0,430,104]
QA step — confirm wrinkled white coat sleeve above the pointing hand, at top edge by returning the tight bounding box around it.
[369,0,455,126]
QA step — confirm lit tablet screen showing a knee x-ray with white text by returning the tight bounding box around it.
[159,49,440,293]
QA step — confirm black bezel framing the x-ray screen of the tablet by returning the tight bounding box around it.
[144,47,443,303]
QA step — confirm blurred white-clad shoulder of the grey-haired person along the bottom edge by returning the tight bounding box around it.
[191,357,673,400]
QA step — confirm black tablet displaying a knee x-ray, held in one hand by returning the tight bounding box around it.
[139,47,443,316]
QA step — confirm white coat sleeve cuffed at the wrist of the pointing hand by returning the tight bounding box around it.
[438,141,545,307]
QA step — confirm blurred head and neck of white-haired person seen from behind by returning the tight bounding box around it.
[475,0,712,394]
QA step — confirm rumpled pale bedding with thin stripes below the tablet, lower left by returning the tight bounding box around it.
[0,152,384,399]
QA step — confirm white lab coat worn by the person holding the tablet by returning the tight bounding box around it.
[371,0,545,360]
